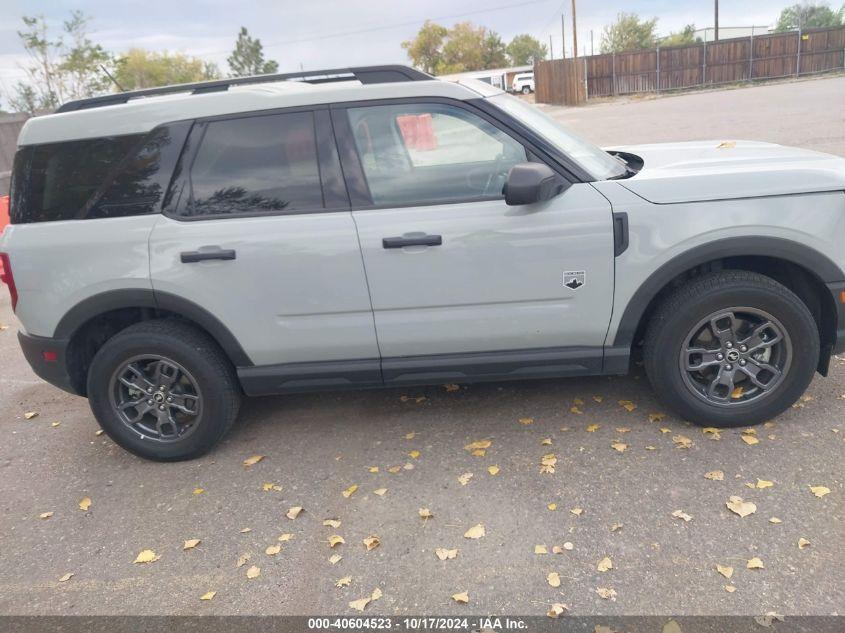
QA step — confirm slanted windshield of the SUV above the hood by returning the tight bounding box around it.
[489,94,625,180]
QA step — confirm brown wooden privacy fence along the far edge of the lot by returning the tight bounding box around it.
[534,27,845,105]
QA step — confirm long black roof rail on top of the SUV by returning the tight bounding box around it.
[56,65,434,112]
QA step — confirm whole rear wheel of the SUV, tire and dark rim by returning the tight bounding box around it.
[88,319,241,461]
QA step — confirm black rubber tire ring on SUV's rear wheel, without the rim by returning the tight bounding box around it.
[88,333,234,461]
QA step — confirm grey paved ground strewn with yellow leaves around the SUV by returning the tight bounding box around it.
[0,78,845,616]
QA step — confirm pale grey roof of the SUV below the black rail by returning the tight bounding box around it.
[18,68,495,146]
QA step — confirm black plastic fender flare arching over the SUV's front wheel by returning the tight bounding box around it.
[613,235,845,349]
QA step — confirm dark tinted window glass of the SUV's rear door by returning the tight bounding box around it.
[182,112,323,216]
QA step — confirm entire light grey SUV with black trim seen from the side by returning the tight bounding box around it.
[0,66,845,460]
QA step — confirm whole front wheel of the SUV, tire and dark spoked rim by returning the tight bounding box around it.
[644,271,819,428]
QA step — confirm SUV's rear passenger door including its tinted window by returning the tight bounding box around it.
[150,109,380,392]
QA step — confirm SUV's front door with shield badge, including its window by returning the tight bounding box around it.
[335,103,614,382]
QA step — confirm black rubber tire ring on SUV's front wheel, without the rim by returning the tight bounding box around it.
[649,285,819,427]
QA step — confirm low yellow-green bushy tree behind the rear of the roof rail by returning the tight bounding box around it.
[114,48,220,90]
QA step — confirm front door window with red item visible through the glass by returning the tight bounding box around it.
[348,103,527,206]
